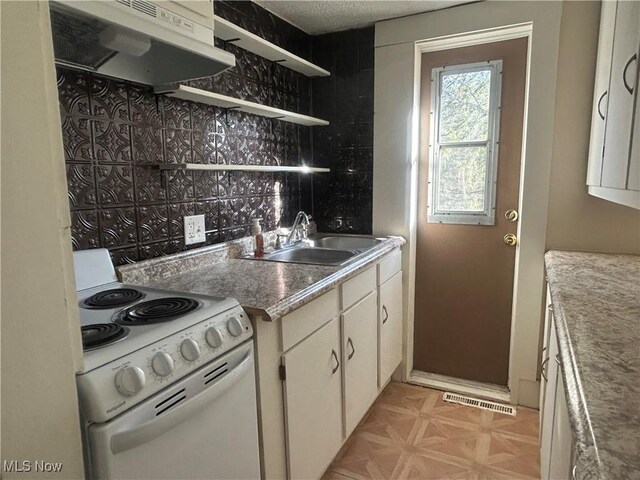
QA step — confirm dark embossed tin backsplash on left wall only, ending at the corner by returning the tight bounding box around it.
[58,1,312,264]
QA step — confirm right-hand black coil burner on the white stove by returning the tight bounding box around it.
[115,297,200,325]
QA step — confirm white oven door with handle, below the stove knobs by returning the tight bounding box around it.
[88,342,260,480]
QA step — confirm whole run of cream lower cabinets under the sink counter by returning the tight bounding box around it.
[276,249,402,480]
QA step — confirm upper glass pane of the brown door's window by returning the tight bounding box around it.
[440,70,491,142]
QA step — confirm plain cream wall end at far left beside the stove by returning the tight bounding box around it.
[0,1,84,478]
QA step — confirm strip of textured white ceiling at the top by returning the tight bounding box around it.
[254,0,474,35]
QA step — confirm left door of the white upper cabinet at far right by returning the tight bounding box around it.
[587,1,617,186]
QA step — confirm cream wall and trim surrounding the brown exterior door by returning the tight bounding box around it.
[373,1,562,406]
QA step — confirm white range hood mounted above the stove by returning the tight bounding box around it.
[49,0,236,85]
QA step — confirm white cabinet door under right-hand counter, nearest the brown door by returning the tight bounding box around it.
[540,314,558,480]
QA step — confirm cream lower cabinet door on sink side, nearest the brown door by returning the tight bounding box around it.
[378,271,402,387]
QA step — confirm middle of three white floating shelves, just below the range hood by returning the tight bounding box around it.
[154,84,329,127]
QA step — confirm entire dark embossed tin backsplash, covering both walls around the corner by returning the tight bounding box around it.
[58,1,373,265]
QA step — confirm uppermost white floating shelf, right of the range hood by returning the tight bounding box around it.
[213,15,331,77]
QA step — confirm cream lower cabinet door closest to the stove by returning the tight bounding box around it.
[282,318,342,479]
